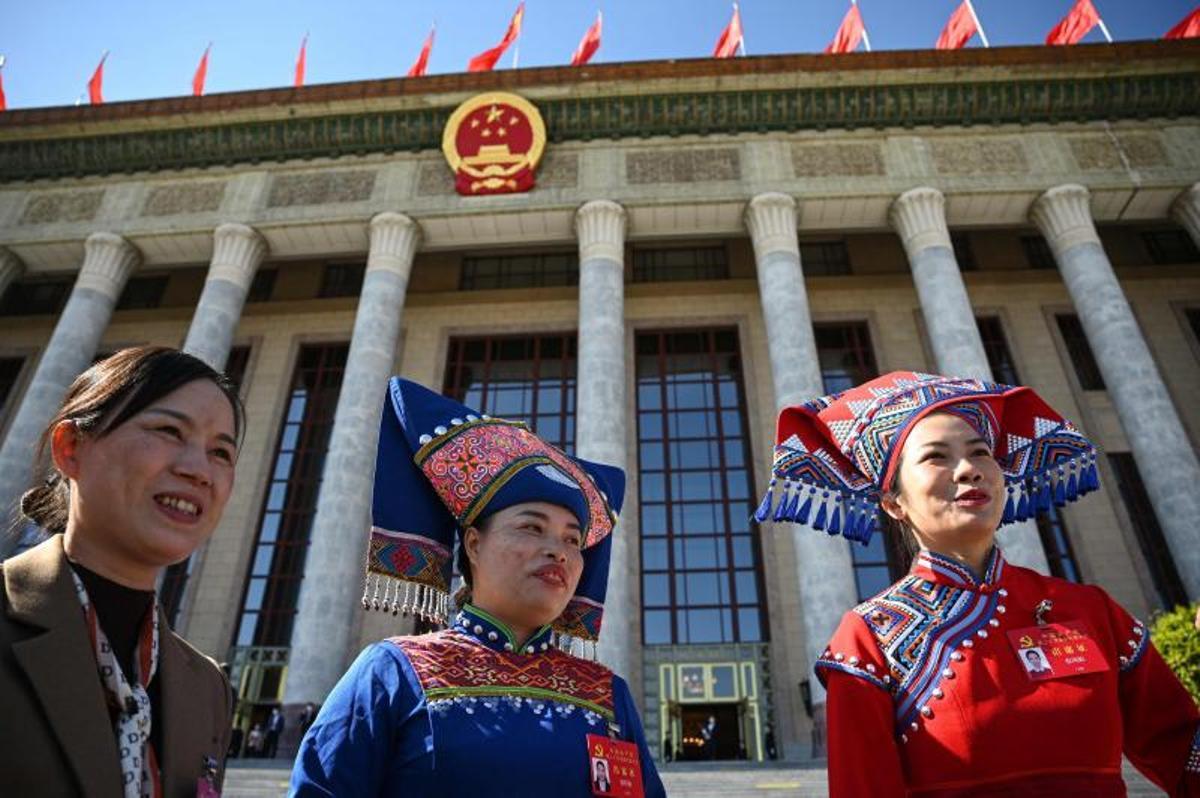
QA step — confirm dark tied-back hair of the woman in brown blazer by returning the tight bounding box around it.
[20,347,245,534]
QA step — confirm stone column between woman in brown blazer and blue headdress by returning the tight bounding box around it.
[284,212,420,704]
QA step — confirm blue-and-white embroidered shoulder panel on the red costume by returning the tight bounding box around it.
[854,575,1000,733]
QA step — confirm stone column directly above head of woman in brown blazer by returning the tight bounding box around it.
[184,223,266,371]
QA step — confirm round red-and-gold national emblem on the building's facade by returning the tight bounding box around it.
[442,91,546,197]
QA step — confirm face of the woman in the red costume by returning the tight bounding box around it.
[882,413,1004,551]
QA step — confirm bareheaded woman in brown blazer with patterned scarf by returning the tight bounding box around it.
[0,347,241,798]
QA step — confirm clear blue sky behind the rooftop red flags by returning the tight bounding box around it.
[0,0,1195,108]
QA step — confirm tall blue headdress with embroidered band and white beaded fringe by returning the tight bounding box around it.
[362,377,625,642]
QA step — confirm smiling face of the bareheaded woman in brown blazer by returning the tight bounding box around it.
[52,379,238,572]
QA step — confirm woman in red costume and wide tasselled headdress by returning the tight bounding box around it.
[757,372,1200,798]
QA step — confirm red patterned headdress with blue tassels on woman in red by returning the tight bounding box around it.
[755,371,1100,545]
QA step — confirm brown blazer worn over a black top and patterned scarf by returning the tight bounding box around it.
[0,535,232,798]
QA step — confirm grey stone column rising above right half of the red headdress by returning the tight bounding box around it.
[889,186,1050,574]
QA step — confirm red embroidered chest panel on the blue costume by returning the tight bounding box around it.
[389,630,614,720]
